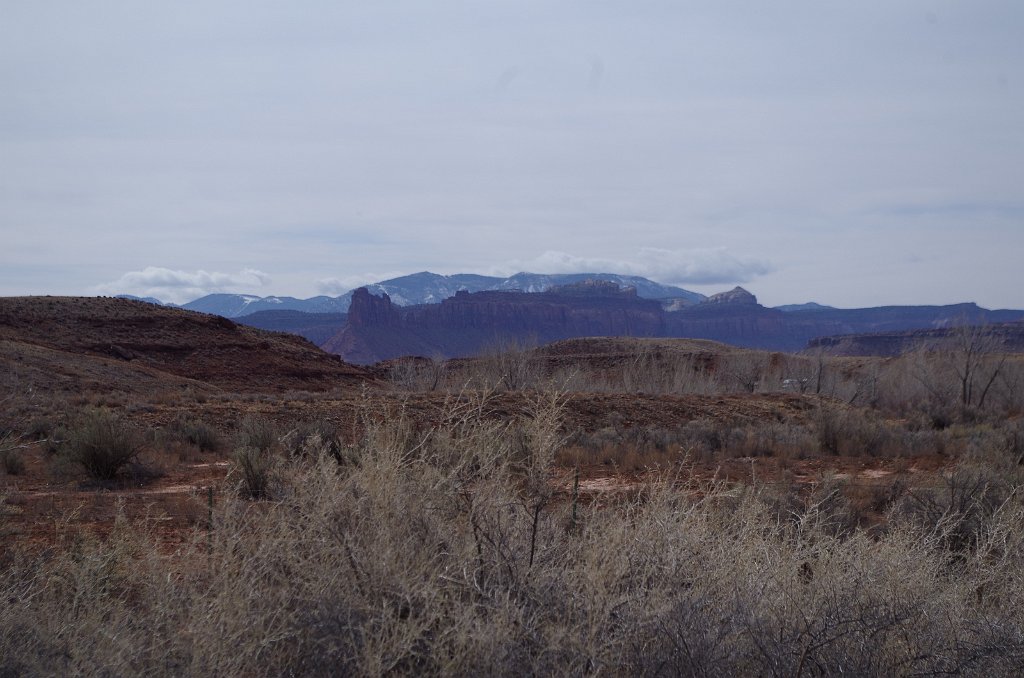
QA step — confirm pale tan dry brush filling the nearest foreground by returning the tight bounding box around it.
[6,394,1024,676]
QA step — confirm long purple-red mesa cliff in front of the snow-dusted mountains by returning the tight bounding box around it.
[323,281,1024,365]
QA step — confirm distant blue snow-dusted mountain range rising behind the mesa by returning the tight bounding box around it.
[120,271,705,317]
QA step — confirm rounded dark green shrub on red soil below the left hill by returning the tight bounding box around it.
[61,410,141,480]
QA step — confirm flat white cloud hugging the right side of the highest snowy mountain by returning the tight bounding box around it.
[491,247,774,285]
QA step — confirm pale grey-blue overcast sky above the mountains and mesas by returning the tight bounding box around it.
[0,0,1024,308]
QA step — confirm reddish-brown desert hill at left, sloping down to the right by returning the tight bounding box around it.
[0,297,367,391]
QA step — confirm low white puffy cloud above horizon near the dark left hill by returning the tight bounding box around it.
[95,266,270,303]
